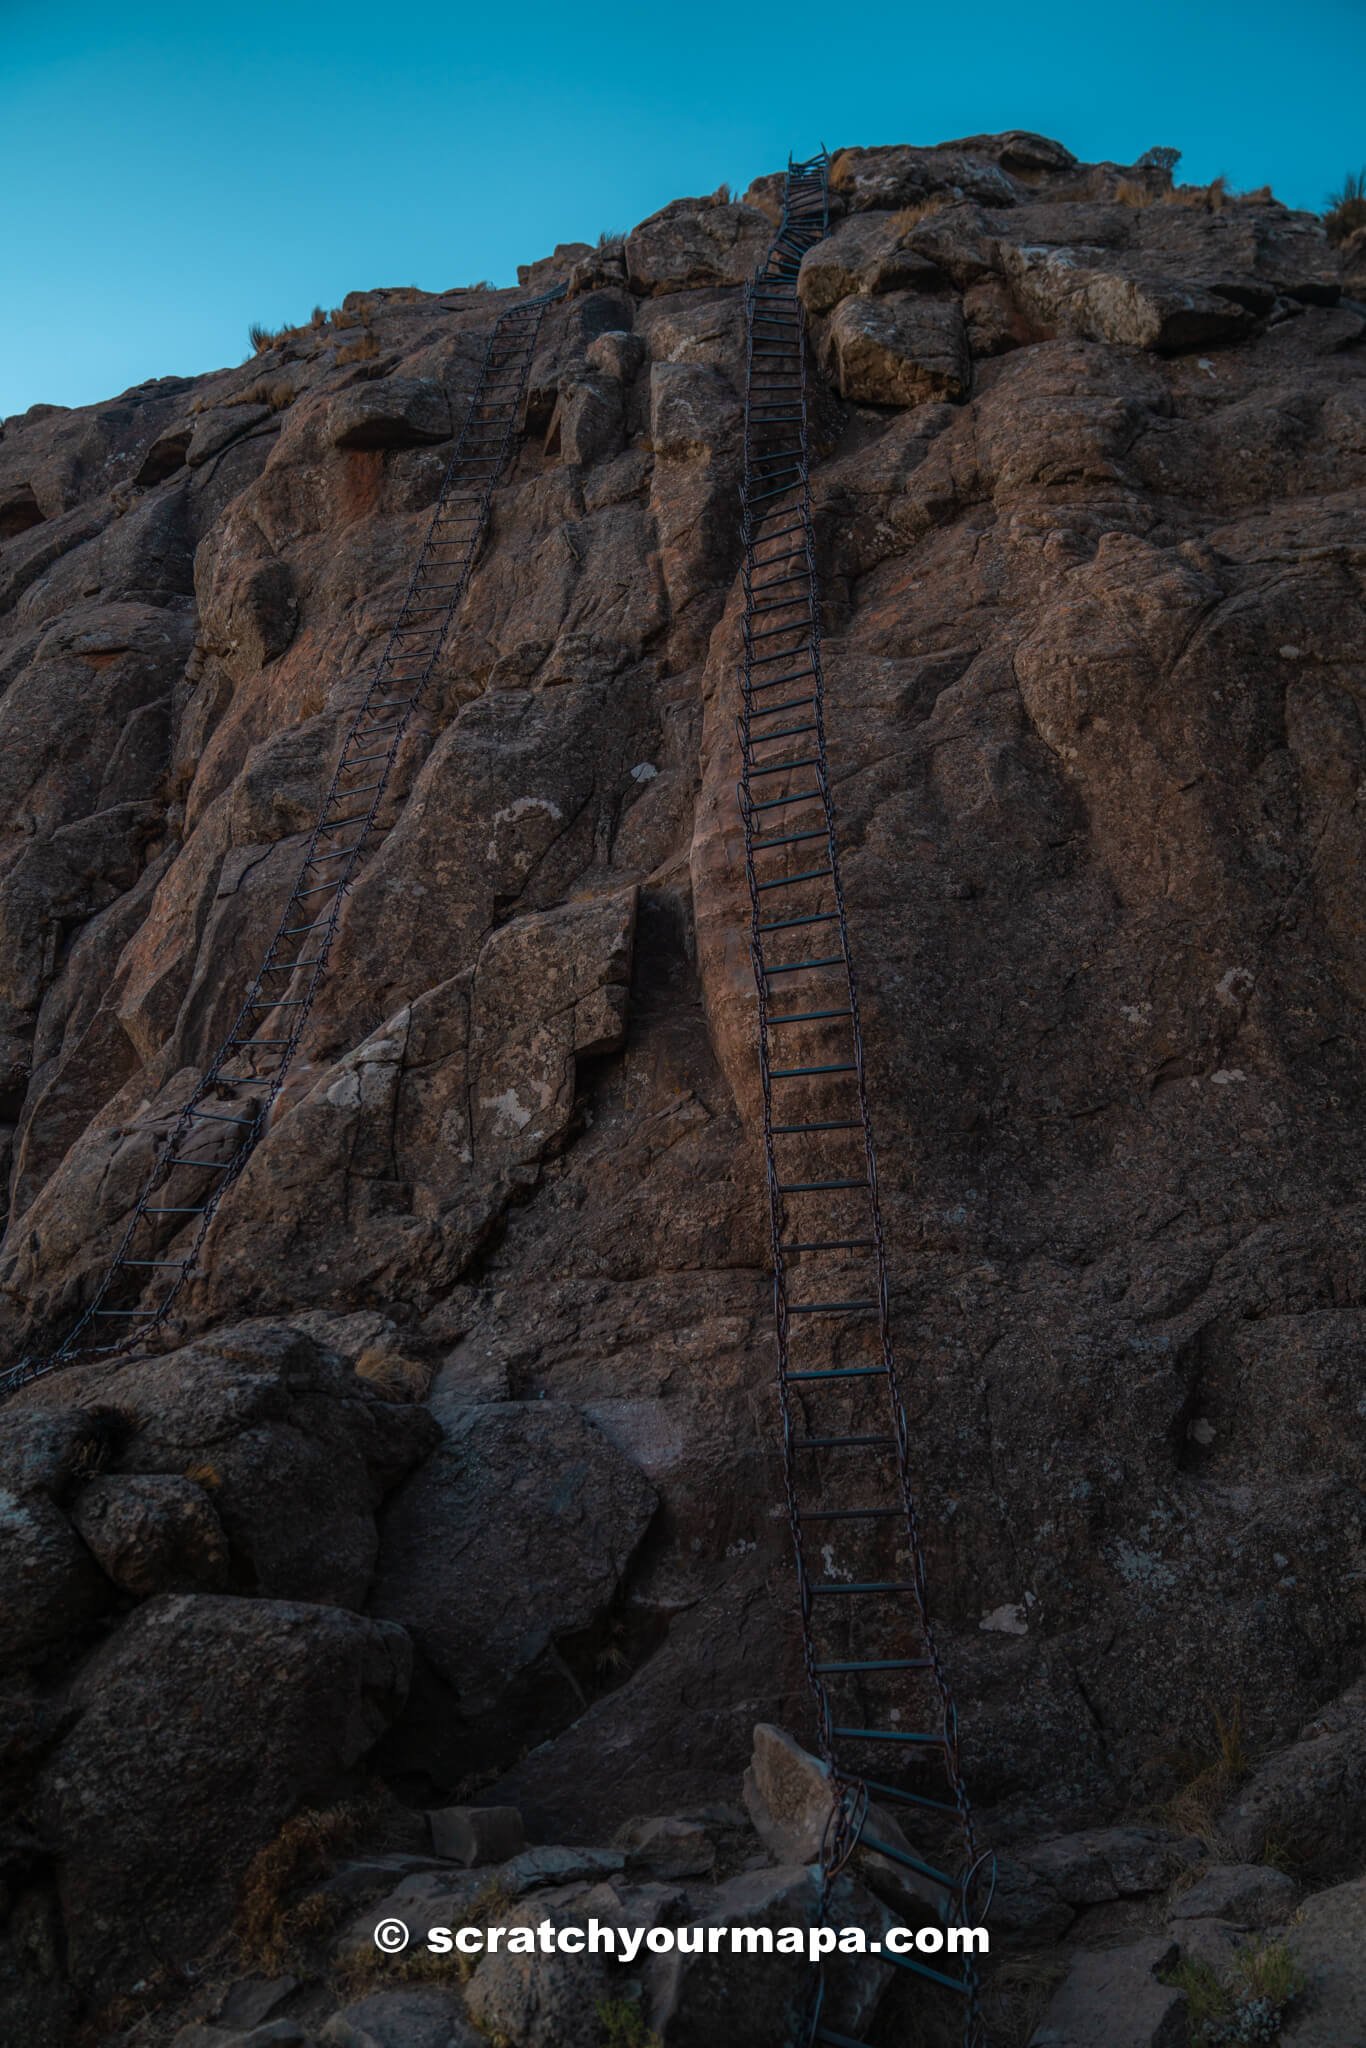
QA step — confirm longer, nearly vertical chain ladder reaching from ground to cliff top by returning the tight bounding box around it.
[737,152,989,2048]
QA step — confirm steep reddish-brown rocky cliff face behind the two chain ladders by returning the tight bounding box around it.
[0,131,1366,2048]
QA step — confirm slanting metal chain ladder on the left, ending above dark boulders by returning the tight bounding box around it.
[0,285,563,1395]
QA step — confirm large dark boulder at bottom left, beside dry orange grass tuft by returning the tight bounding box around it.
[39,1595,410,1985]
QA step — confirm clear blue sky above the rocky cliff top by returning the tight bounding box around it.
[0,0,1366,416]
